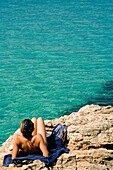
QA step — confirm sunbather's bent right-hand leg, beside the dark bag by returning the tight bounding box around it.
[37,117,47,146]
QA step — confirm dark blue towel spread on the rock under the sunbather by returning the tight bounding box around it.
[3,129,69,166]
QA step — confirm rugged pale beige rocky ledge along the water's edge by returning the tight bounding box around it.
[0,105,113,170]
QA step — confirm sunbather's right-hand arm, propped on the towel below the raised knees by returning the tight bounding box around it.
[37,134,49,156]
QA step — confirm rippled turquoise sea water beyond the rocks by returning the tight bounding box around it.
[0,0,113,145]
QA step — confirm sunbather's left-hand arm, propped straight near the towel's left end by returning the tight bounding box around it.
[12,135,19,159]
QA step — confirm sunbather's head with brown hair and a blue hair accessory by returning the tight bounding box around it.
[20,119,34,139]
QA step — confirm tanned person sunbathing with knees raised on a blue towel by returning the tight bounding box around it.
[12,117,49,159]
